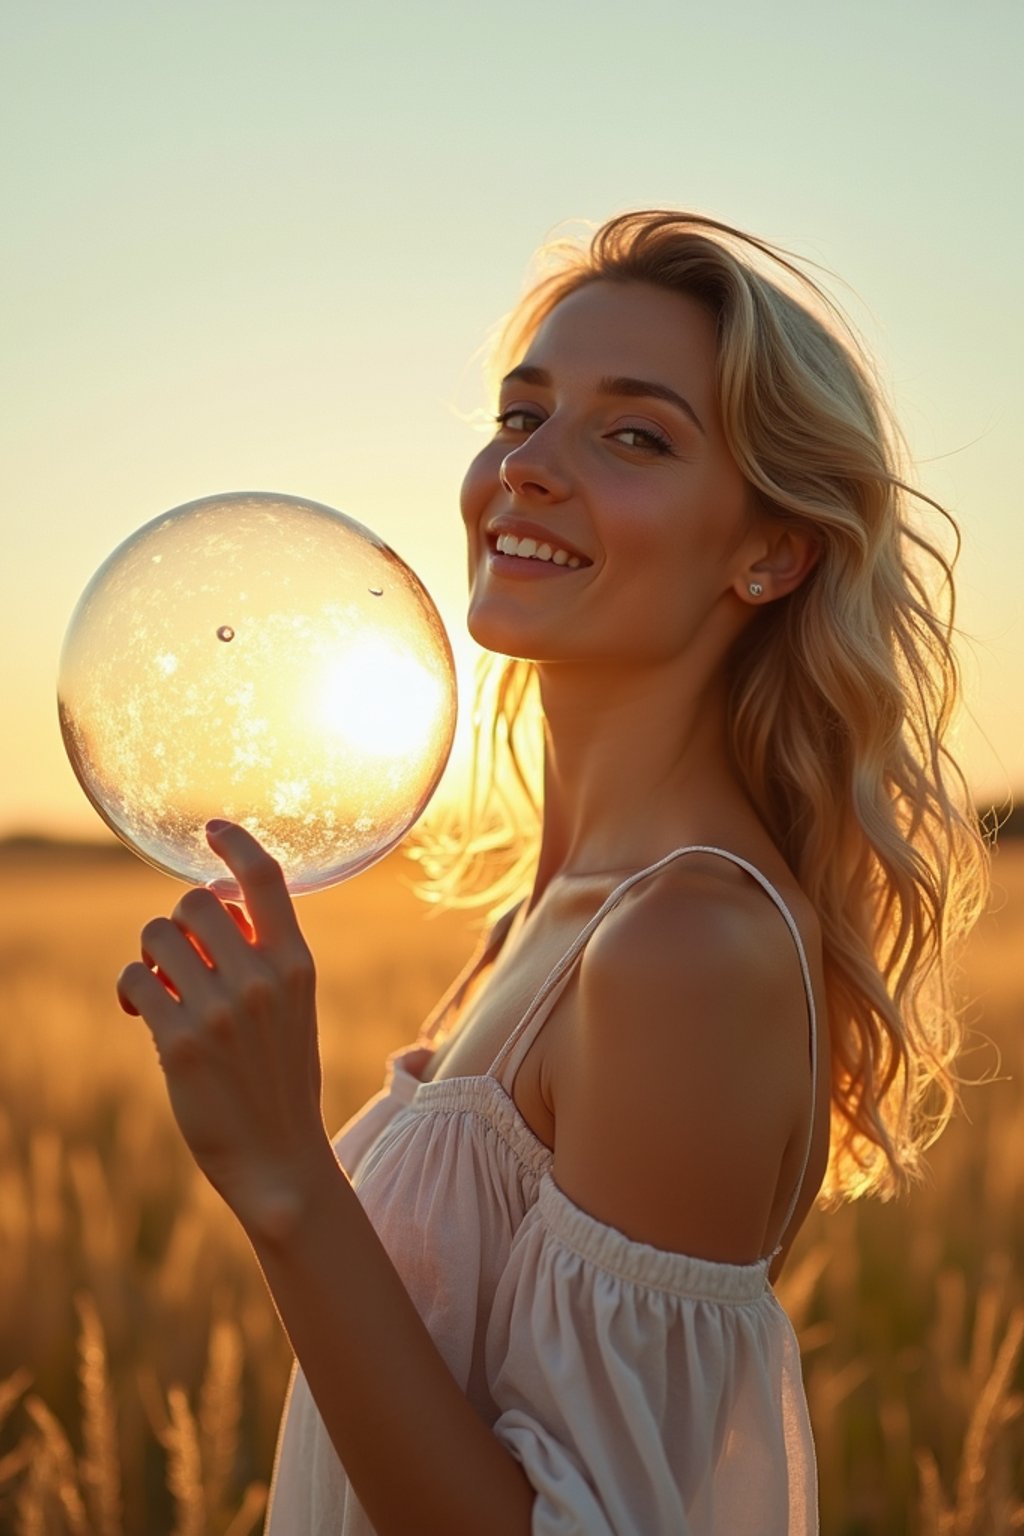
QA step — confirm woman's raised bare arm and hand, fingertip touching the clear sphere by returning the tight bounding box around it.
[118,825,533,1536]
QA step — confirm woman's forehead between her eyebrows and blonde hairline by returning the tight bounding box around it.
[522,281,715,404]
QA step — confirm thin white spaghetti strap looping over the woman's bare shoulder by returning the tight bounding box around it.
[487,843,818,1263]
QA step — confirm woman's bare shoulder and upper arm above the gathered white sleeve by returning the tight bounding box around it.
[551,854,817,1263]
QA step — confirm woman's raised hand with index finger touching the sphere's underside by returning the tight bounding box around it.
[117,822,327,1233]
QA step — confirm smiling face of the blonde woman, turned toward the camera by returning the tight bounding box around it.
[462,281,757,662]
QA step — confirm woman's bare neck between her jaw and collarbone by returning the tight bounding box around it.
[533,651,751,903]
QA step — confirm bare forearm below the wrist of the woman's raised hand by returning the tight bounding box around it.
[249,1143,533,1536]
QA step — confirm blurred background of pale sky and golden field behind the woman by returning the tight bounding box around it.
[0,0,1024,1536]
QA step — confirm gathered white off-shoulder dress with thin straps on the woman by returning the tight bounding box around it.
[266,848,818,1536]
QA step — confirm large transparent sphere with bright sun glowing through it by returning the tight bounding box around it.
[58,492,456,894]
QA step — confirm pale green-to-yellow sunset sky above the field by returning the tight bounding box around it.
[0,0,1024,836]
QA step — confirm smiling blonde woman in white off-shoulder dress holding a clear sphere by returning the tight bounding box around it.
[120,212,983,1536]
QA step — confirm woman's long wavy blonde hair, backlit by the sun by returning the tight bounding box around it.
[419,210,987,1200]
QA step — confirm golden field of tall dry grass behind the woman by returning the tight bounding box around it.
[0,843,1024,1536]
